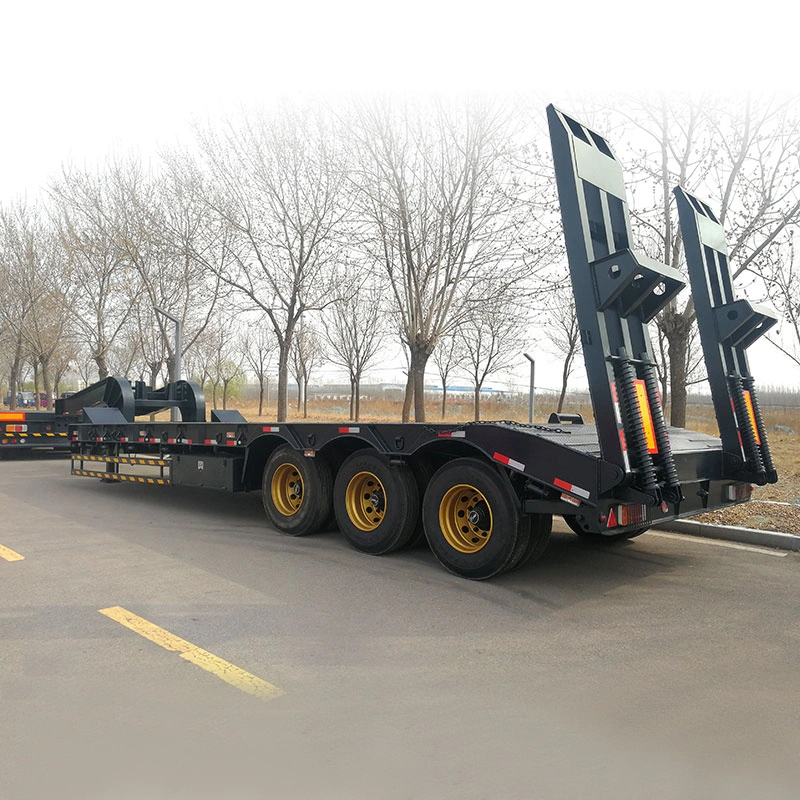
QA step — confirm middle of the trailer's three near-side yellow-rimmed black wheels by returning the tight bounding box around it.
[333,450,419,556]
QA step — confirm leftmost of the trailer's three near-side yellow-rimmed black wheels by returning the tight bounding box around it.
[261,445,333,536]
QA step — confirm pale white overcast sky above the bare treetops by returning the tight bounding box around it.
[0,0,800,384]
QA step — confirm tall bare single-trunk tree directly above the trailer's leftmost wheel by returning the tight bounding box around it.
[191,103,347,421]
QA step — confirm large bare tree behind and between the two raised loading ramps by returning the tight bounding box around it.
[618,96,800,426]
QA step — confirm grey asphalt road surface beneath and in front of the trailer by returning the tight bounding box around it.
[0,456,800,800]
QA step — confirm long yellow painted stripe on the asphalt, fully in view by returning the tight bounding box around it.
[100,606,283,700]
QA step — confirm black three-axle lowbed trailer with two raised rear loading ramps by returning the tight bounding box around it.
[63,106,777,579]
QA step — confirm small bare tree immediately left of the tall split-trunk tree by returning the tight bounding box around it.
[325,286,385,421]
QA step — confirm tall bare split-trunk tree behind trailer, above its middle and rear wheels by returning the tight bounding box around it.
[351,98,523,421]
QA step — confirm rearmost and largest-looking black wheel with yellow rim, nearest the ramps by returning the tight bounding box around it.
[422,458,529,580]
